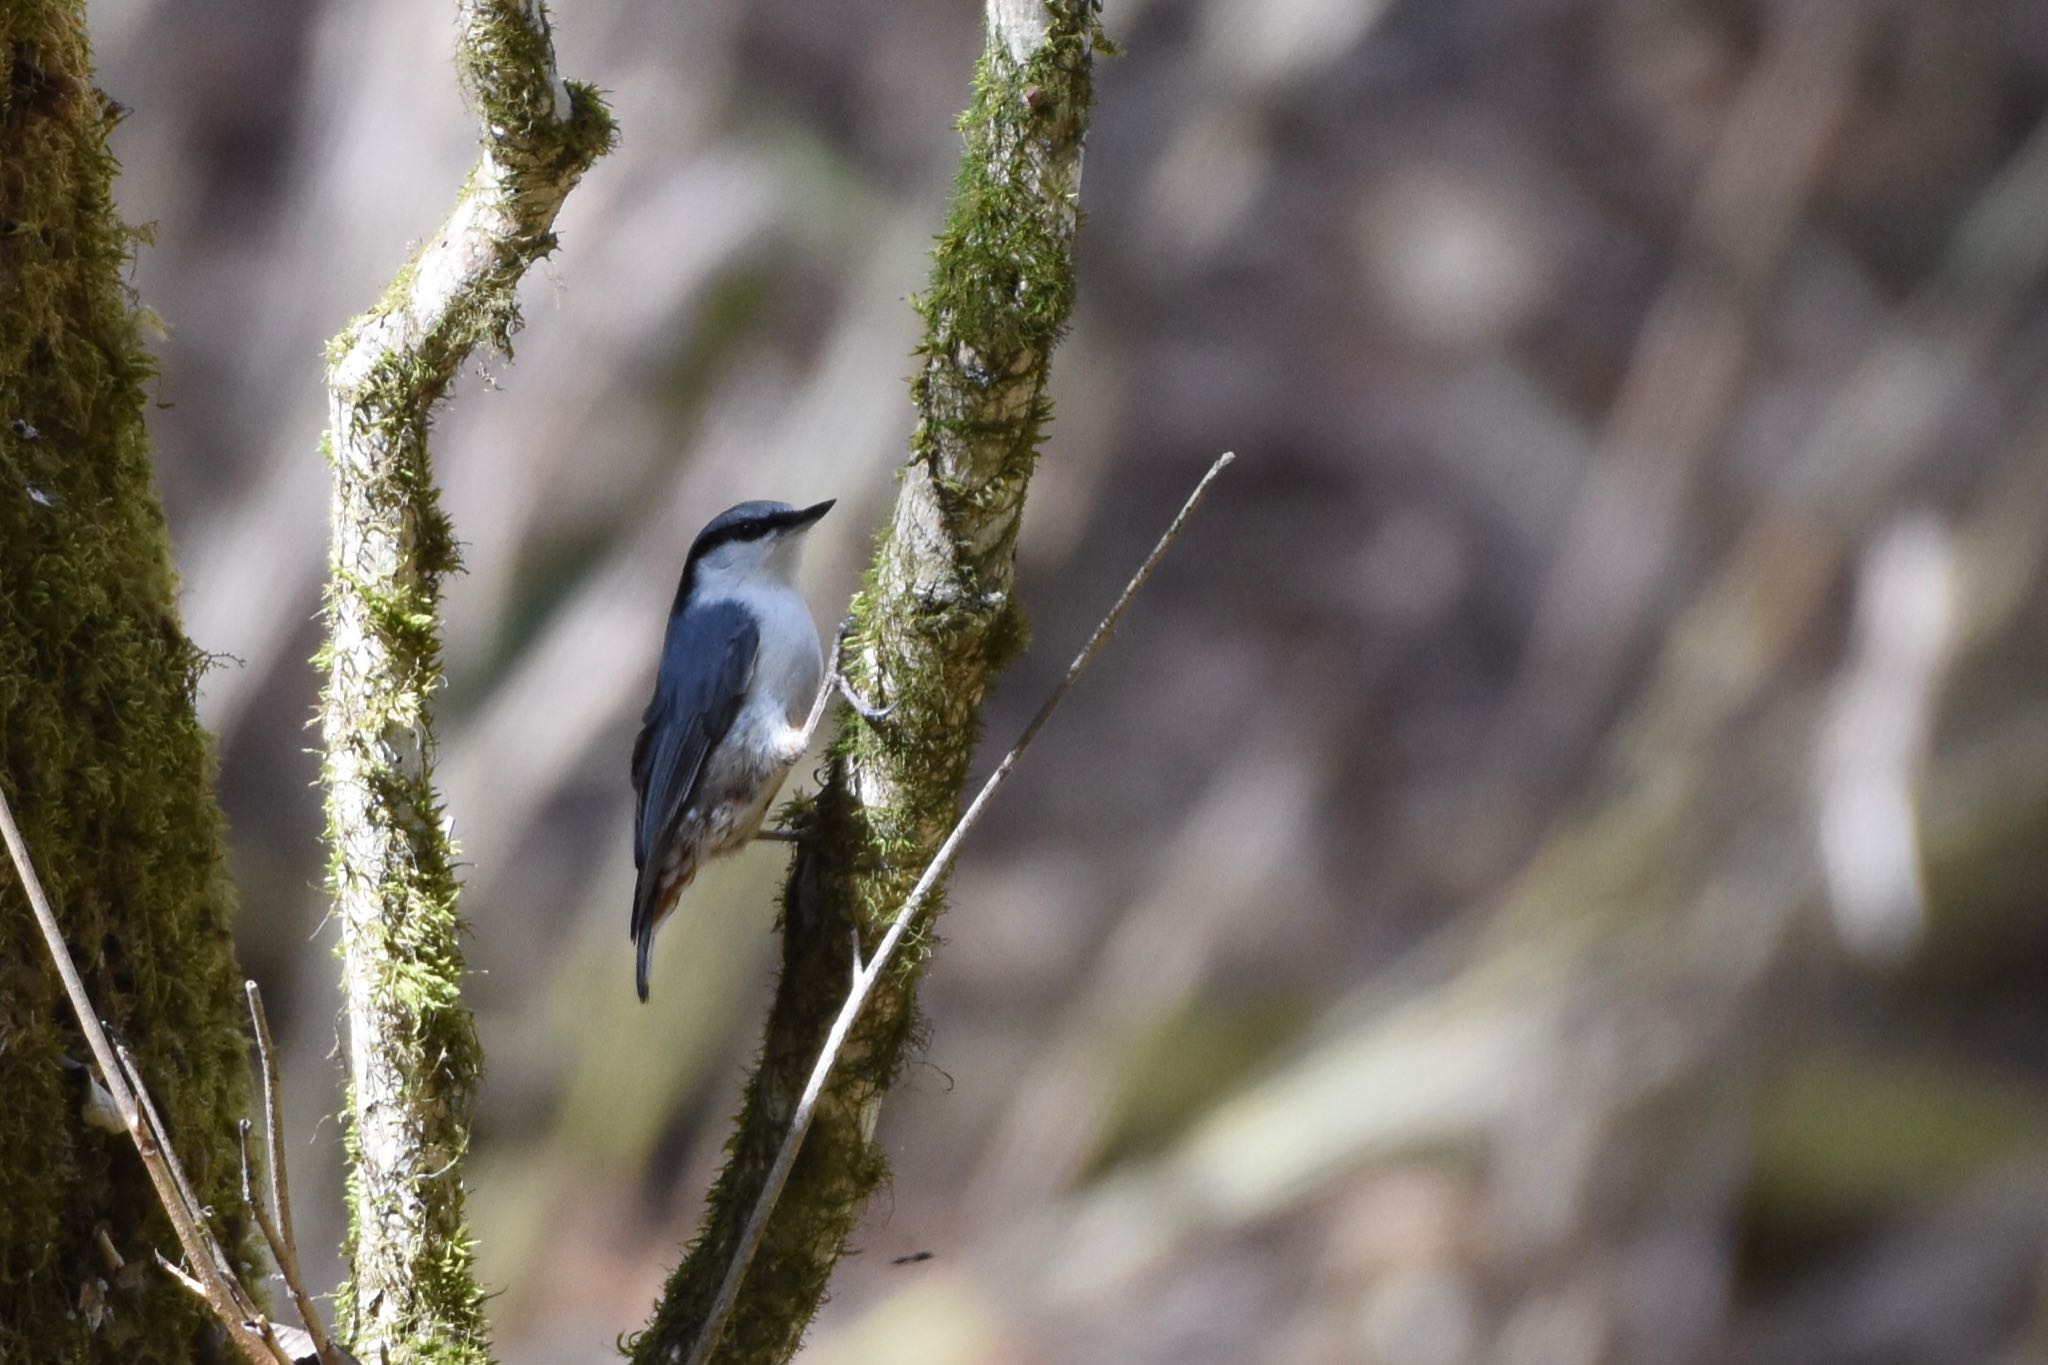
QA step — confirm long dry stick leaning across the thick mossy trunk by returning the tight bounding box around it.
[0,792,291,1365]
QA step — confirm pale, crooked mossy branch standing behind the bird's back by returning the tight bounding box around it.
[322,0,614,1361]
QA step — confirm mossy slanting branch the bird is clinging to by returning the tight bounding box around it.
[633,0,1102,1365]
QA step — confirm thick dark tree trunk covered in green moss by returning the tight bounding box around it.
[0,0,248,1365]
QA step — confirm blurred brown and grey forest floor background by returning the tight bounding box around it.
[92,0,2048,1365]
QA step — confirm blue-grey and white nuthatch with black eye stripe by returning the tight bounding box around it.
[633,501,839,1001]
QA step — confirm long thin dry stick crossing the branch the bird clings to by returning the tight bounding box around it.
[688,452,1237,1365]
